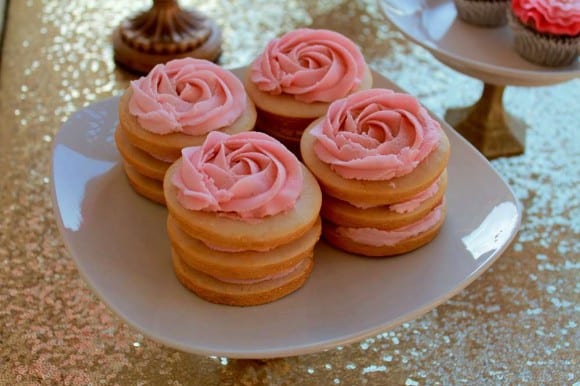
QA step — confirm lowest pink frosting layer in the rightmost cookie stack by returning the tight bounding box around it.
[336,204,443,247]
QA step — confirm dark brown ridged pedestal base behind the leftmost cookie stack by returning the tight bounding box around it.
[113,0,221,74]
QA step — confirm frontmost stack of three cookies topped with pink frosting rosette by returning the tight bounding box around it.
[164,131,322,306]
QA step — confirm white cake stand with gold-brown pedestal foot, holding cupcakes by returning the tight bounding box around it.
[378,0,580,159]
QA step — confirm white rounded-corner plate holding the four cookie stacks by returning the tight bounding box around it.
[52,69,521,358]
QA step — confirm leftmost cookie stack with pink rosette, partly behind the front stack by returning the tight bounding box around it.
[115,58,256,204]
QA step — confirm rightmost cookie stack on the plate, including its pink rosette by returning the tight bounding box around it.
[301,89,450,256]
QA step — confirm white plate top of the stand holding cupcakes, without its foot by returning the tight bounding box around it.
[378,0,580,86]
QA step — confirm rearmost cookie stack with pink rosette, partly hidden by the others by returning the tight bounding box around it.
[244,28,372,155]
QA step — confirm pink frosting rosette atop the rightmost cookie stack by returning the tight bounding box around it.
[311,89,440,181]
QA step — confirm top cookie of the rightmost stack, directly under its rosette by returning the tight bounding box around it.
[300,118,450,206]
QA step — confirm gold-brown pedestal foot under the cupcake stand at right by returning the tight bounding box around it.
[445,83,526,159]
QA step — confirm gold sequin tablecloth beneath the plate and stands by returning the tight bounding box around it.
[0,0,580,385]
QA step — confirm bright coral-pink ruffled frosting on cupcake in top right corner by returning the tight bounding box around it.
[512,0,580,36]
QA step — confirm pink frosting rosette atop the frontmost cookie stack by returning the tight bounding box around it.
[172,131,303,219]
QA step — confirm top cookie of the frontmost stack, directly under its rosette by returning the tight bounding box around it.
[163,160,322,250]
